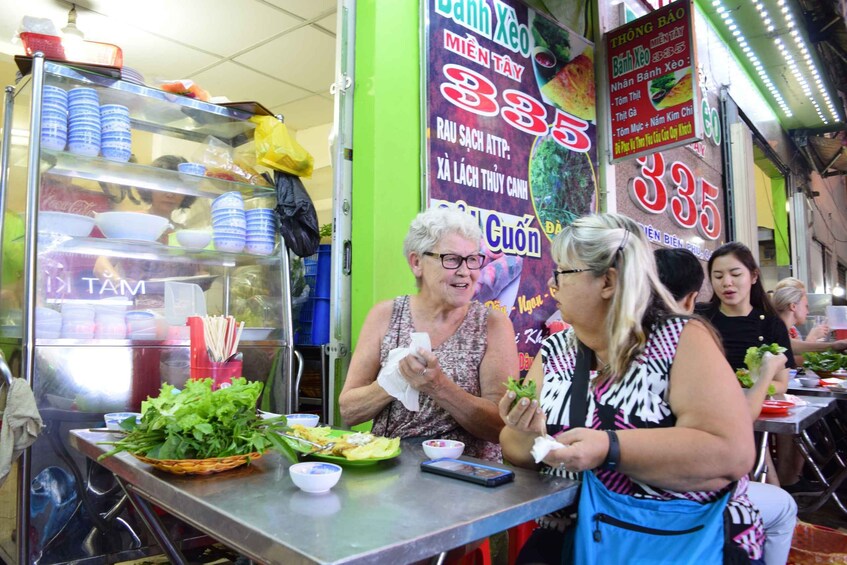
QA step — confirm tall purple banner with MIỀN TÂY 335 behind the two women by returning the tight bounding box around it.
[422,0,598,370]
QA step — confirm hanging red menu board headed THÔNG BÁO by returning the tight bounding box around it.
[606,0,701,162]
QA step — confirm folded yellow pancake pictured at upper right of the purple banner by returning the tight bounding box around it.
[541,47,596,121]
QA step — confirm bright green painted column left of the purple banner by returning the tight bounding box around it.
[351,0,421,348]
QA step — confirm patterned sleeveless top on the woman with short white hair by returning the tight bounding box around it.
[373,296,503,462]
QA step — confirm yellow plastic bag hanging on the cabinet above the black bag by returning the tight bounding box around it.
[255,116,315,177]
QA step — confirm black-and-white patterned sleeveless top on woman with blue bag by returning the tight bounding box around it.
[539,318,765,559]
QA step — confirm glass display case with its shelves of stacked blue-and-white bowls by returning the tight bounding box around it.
[0,56,296,563]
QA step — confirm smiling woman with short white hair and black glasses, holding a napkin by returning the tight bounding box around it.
[338,208,518,461]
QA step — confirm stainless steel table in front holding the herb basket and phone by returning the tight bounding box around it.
[70,430,578,564]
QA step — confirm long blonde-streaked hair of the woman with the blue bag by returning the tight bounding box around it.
[552,214,685,381]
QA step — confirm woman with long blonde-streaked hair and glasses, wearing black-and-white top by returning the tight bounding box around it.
[500,214,763,563]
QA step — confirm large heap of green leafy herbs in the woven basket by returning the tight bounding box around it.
[98,378,297,461]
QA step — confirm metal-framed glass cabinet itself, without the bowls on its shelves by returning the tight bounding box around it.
[0,55,296,564]
